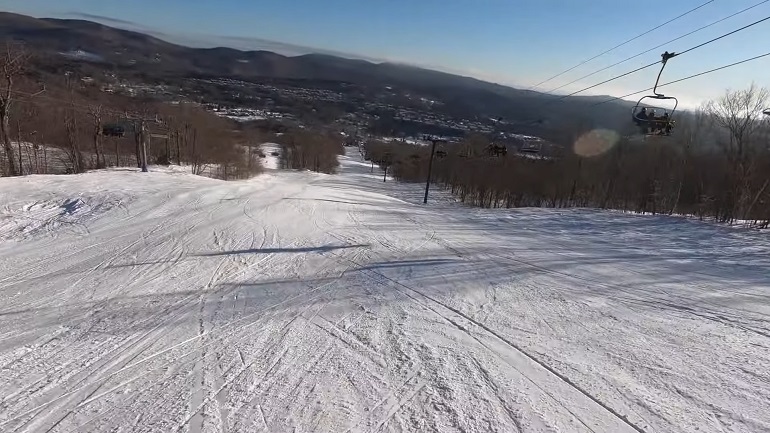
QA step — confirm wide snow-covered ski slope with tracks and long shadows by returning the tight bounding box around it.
[0,149,770,433]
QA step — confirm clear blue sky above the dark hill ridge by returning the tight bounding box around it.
[0,0,770,106]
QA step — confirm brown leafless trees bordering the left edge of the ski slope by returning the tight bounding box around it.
[0,45,264,179]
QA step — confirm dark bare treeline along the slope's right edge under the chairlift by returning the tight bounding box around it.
[366,85,770,227]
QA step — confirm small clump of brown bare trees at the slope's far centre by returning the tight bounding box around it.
[276,128,345,174]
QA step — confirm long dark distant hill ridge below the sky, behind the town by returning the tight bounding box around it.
[0,13,631,134]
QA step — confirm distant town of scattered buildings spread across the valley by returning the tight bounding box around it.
[90,74,554,154]
